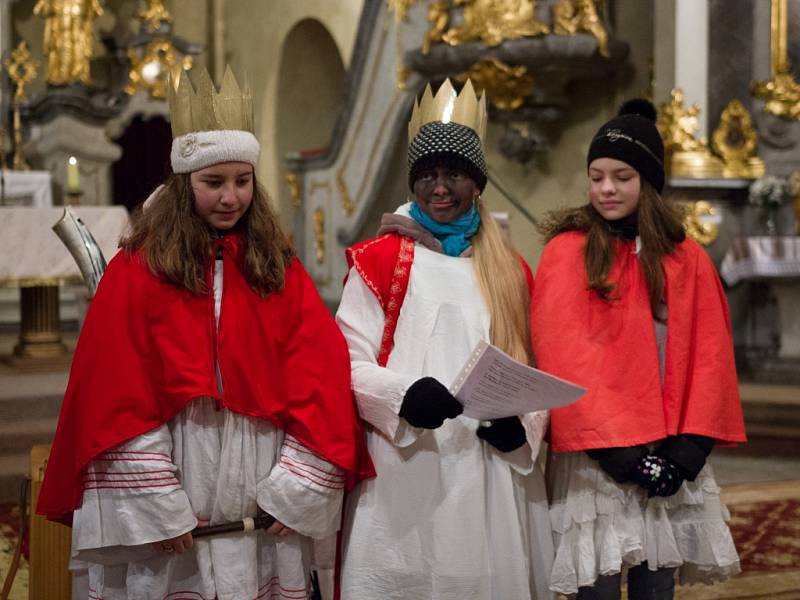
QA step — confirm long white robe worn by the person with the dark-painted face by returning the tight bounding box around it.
[336,207,553,600]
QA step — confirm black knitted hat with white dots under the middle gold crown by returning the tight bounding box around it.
[408,121,486,192]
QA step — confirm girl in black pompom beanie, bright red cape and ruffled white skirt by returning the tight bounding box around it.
[531,101,745,600]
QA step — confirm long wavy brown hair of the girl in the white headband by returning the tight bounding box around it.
[120,173,294,296]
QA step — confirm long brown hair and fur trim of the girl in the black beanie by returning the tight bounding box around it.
[539,178,686,317]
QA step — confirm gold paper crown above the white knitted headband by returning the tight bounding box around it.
[169,65,255,138]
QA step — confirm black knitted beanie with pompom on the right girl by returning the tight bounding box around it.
[586,98,665,193]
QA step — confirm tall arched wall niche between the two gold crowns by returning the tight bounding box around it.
[272,19,346,230]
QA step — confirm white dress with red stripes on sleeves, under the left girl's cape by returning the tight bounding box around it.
[72,260,344,600]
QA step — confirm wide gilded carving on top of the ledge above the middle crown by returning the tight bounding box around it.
[442,0,550,47]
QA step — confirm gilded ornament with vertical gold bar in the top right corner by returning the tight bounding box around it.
[751,0,800,121]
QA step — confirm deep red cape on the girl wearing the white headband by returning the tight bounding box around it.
[37,235,374,522]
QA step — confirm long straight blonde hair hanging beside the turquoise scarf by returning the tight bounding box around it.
[472,198,533,364]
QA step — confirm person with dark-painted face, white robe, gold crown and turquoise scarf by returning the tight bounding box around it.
[336,82,552,600]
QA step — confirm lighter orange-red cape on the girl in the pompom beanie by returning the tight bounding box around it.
[531,232,746,452]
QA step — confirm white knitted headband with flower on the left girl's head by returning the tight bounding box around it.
[170,130,261,173]
